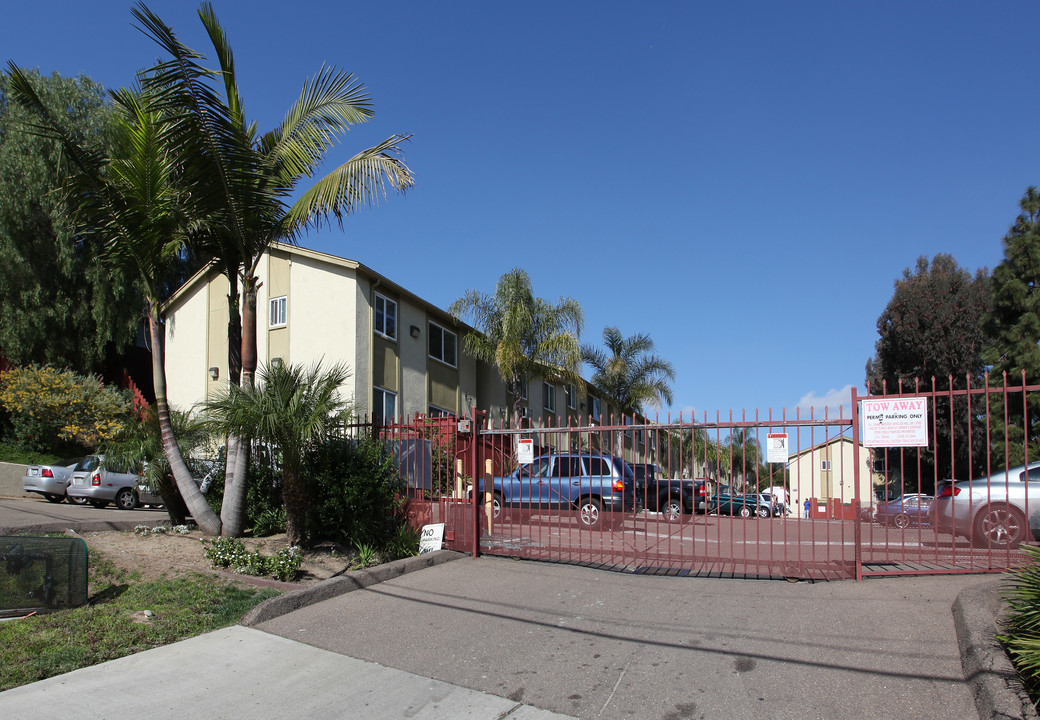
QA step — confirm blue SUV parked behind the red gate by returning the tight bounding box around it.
[478,453,635,529]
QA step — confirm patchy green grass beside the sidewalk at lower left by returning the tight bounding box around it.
[0,551,279,691]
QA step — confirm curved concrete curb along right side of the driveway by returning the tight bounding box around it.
[953,580,1040,720]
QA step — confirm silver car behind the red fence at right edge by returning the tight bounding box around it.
[933,463,1040,549]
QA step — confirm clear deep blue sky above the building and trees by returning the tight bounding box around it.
[0,0,1040,419]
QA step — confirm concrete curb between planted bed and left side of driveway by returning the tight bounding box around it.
[238,550,469,627]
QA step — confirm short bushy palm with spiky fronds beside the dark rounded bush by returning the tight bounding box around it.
[206,362,348,545]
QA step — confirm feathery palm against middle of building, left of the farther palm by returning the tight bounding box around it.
[449,267,583,425]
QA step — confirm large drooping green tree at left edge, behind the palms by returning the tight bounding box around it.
[0,71,140,372]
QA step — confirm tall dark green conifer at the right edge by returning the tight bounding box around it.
[983,187,1040,465]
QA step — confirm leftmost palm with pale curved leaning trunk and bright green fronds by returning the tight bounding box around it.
[7,71,220,535]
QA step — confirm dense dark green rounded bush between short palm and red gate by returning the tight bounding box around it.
[304,438,403,547]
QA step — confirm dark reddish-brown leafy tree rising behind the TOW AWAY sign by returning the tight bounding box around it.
[866,253,991,489]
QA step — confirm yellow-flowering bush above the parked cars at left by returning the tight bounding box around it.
[0,365,132,451]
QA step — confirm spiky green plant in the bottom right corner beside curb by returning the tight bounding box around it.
[996,545,1040,703]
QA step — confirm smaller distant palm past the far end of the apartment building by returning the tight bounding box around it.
[581,327,675,448]
